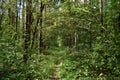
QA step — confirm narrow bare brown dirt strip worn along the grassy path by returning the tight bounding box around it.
[50,56,60,80]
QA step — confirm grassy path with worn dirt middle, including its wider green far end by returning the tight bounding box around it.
[49,48,65,80]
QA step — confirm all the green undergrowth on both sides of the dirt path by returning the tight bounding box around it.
[0,44,120,80]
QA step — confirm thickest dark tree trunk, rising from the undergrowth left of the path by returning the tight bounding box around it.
[23,0,32,62]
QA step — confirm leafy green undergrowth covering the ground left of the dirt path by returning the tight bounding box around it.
[0,44,56,80]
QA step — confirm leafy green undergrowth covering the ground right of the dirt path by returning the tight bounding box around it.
[60,49,120,80]
